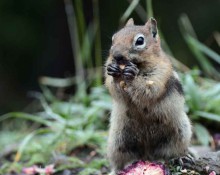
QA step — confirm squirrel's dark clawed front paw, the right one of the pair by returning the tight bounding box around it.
[123,62,139,80]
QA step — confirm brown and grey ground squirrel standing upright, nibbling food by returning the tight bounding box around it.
[105,18,192,172]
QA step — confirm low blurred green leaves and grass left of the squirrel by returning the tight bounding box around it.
[0,86,111,173]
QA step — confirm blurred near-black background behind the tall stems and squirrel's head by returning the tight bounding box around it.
[0,0,220,114]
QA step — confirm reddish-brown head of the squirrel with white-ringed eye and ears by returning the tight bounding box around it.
[109,18,161,63]
